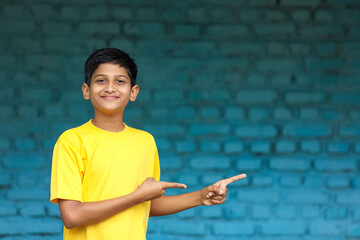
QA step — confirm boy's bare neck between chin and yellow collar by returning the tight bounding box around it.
[91,112,125,132]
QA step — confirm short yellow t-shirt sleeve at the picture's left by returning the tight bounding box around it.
[50,132,83,203]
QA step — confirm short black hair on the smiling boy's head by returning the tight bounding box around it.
[85,48,137,87]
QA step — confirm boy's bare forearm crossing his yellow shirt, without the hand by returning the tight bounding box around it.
[59,191,143,228]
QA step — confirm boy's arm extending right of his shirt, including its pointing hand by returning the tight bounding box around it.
[150,174,246,217]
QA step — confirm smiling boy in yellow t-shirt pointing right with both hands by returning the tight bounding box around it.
[50,48,246,240]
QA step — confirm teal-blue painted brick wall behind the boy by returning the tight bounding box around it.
[0,0,360,240]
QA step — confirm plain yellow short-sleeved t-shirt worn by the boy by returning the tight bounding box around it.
[50,120,160,240]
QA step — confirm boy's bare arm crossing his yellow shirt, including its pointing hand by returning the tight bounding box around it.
[59,178,186,228]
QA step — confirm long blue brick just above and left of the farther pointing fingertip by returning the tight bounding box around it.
[189,155,230,171]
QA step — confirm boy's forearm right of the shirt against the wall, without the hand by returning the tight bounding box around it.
[150,190,203,217]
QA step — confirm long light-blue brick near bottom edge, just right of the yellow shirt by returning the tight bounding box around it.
[161,221,206,236]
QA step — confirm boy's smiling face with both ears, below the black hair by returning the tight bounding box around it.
[82,63,139,114]
